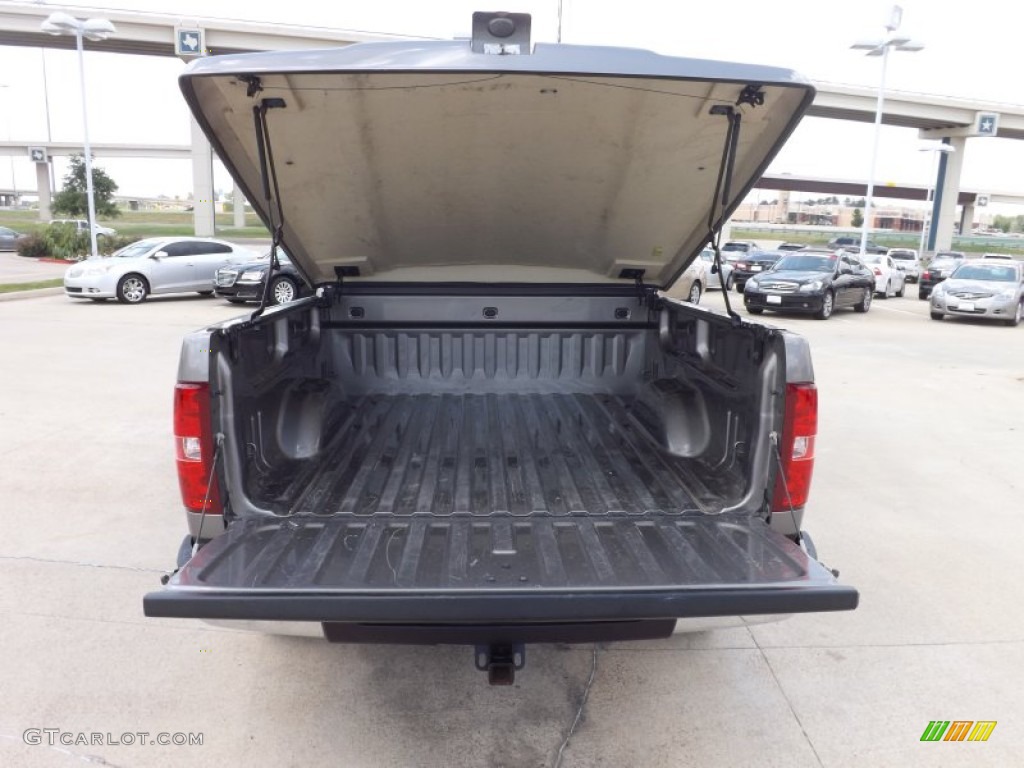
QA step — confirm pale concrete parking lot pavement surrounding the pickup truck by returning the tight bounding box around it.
[0,291,1024,768]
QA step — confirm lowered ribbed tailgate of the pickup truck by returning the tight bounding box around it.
[144,515,858,624]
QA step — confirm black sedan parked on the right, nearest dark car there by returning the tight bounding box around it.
[743,251,874,319]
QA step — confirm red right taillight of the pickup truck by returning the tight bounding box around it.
[771,382,818,512]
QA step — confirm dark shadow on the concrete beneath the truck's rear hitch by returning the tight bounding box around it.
[240,633,756,768]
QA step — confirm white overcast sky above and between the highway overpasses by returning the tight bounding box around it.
[0,0,1024,213]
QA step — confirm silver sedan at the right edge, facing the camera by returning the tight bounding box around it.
[931,261,1024,326]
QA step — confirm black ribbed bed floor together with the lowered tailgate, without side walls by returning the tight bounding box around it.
[145,393,857,625]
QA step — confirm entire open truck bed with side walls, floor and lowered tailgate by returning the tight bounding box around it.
[145,303,857,626]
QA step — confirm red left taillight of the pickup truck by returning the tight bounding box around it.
[174,382,223,515]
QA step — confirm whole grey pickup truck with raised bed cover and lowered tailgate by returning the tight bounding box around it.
[143,14,858,683]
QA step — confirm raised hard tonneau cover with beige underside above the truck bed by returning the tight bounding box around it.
[180,41,814,288]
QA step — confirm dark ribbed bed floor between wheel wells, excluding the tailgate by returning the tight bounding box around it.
[283,393,707,517]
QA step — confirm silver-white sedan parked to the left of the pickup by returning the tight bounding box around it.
[65,238,257,304]
